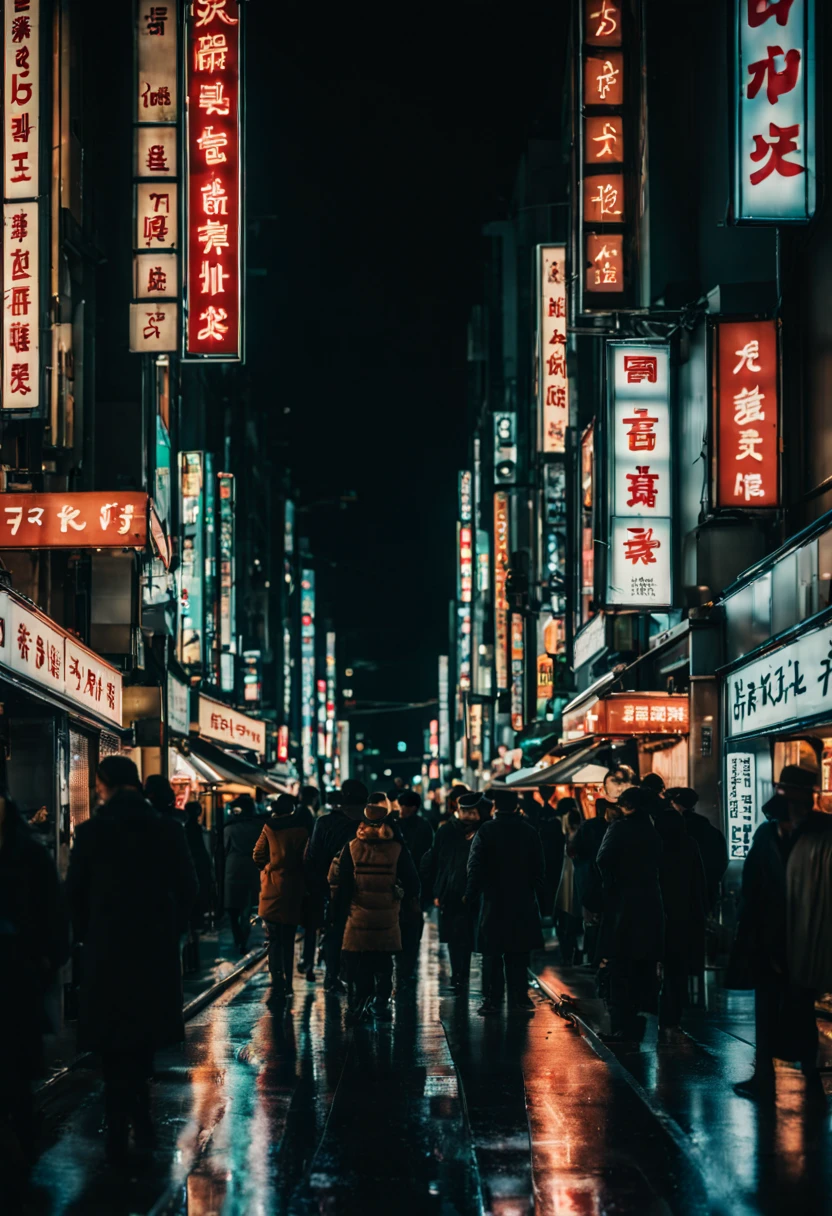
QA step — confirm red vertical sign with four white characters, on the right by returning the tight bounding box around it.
[716,321,780,510]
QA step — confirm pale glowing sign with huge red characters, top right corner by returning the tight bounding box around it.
[733,0,816,224]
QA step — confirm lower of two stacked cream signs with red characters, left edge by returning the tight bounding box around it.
[2,203,40,410]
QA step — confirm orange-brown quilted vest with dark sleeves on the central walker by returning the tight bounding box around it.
[330,821,420,953]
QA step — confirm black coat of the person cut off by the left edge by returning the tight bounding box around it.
[0,804,69,1077]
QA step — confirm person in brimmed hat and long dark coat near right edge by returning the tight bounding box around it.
[729,765,832,1102]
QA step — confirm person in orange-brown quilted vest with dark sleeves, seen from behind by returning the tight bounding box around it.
[328,799,420,1025]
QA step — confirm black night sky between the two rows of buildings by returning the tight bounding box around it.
[247,0,566,749]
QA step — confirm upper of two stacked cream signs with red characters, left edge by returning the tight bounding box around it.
[2,0,40,201]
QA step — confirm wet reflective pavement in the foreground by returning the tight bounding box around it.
[11,924,831,1216]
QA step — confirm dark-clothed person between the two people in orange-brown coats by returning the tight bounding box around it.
[303,778,367,992]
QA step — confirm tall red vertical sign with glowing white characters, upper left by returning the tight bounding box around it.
[185,0,242,361]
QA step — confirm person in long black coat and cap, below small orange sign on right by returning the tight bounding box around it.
[597,787,664,1040]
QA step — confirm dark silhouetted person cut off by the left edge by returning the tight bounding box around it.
[0,790,69,1167]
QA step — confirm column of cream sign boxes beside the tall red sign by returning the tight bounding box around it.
[130,0,181,354]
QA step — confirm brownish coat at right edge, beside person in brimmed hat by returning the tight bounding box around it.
[786,815,832,992]
